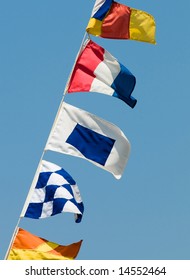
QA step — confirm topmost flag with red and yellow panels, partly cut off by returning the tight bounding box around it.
[86,0,156,44]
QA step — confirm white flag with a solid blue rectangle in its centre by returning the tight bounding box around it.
[45,102,130,179]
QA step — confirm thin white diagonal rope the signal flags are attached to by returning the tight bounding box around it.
[4,32,90,260]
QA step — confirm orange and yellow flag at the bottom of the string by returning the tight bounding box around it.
[7,228,82,260]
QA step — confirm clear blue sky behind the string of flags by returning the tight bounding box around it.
[0,0,190,260]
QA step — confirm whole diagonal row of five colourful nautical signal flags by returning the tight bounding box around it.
[7,0,156,260]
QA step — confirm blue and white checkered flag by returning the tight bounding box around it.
[21,160,84,223]
